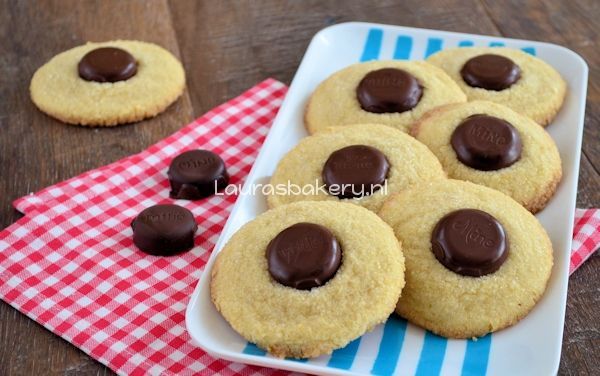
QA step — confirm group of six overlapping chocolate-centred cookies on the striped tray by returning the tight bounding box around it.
[211,48,566,358]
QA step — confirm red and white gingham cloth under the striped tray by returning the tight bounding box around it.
[0,79,600,375]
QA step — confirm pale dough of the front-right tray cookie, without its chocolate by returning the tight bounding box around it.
[379,180,553,338]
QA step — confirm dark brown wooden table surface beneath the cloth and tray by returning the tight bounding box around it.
[0,0,600,375]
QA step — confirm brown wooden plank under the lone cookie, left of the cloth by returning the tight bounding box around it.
[0,0,193,375]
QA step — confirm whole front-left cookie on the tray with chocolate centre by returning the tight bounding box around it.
[210,202,404,358]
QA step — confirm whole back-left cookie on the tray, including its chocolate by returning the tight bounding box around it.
[304,61,466,133]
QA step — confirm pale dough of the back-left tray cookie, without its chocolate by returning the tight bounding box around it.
[304,60,466,133]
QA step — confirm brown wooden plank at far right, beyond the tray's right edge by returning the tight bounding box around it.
[484,0,600,375]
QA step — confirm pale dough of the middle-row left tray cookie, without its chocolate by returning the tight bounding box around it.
[267,124,446,211]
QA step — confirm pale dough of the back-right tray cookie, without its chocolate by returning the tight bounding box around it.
[427,47,567,126]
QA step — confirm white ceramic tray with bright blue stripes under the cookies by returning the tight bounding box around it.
[186,22,588,375]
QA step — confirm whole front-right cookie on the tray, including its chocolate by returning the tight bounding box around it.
[379,179,553,338]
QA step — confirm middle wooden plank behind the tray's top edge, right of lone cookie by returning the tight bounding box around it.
[170,0,497,115]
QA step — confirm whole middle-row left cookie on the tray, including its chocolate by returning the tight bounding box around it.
[267,124,445,211]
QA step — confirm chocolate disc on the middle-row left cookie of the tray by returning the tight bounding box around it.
[322,145,390,198]
